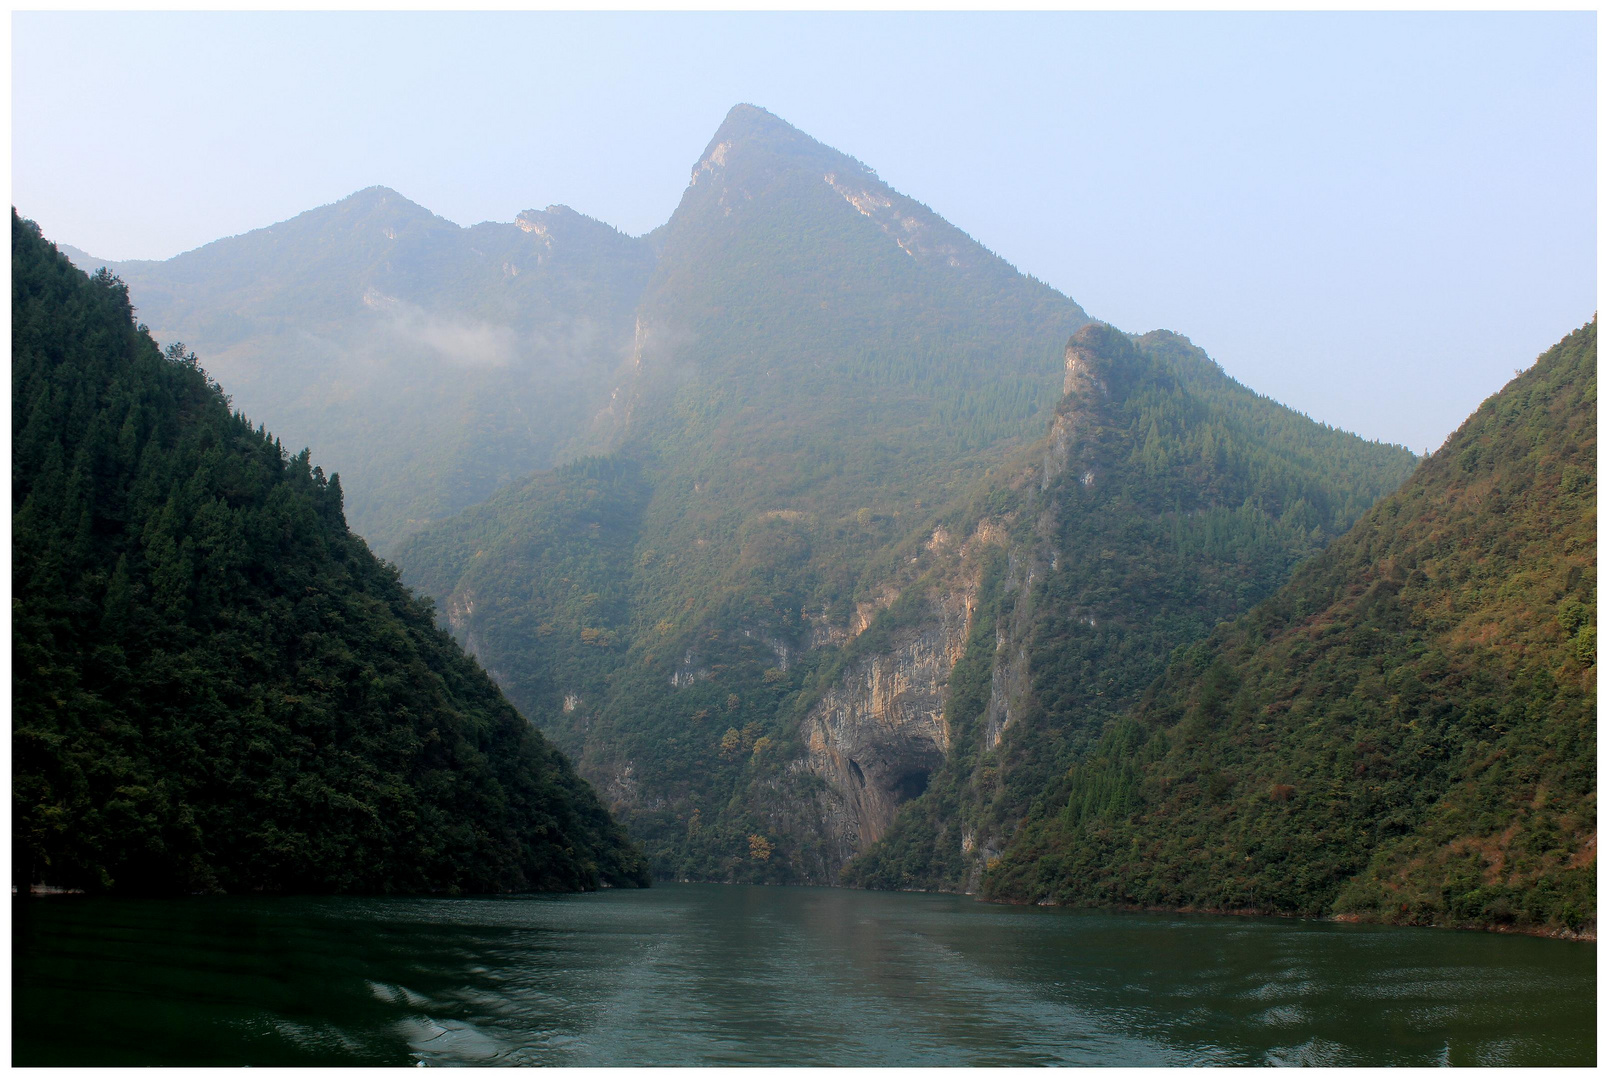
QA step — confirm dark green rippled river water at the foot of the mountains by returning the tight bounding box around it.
[13,886,1597,1066]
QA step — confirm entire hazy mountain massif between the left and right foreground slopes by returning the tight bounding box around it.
[50,106,1413,889]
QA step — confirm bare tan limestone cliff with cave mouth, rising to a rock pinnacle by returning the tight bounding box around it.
[769,328,1118,889]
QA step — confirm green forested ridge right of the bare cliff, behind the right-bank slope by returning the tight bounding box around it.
[844,325,1412,889]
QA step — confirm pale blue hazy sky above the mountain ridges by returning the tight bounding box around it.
[11,13,1597,450]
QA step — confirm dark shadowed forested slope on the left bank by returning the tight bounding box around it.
[11,212,646,894]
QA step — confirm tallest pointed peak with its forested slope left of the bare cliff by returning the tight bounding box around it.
[397,106,1106,874]
